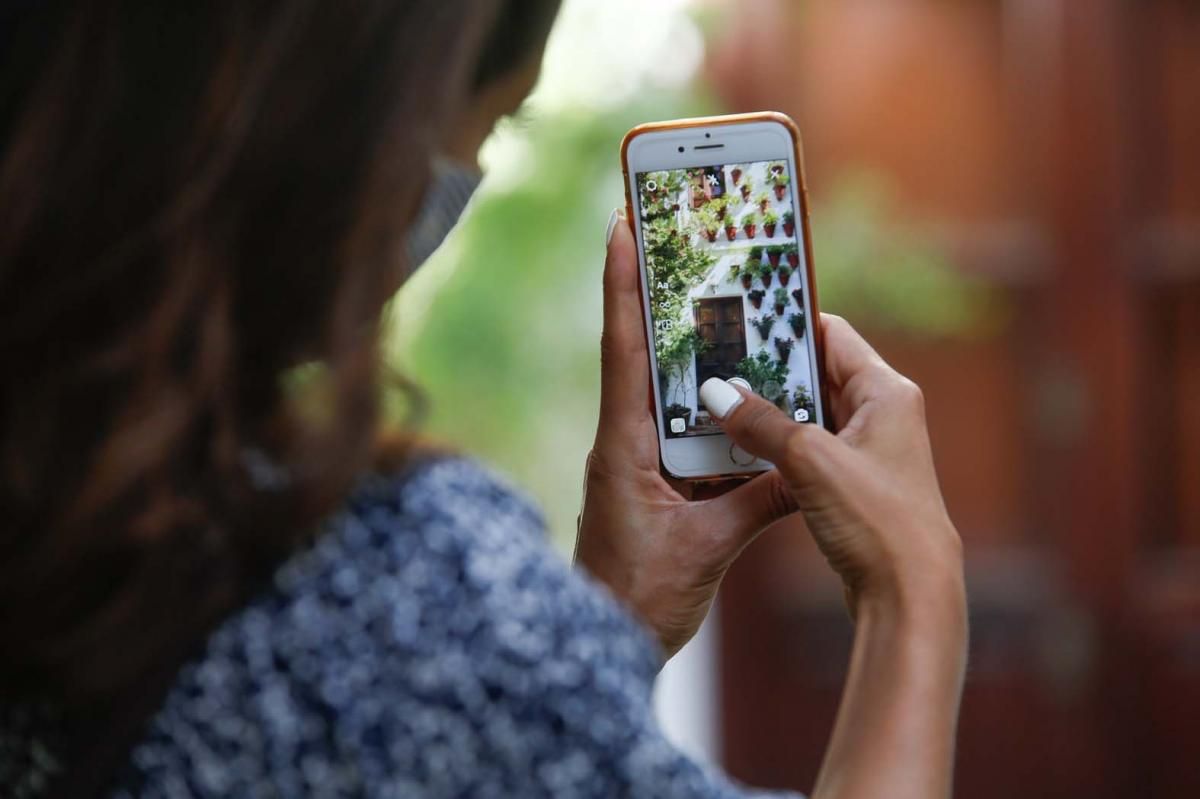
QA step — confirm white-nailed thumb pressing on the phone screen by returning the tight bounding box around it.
[700,378,840,487]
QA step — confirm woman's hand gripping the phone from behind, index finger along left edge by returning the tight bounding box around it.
[576,208,796,657]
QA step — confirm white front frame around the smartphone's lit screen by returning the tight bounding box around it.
[622,112,828,480]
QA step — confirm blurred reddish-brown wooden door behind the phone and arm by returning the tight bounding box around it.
[712,0,1200,799]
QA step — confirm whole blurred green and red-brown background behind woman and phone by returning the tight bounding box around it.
[389,0,1200,798]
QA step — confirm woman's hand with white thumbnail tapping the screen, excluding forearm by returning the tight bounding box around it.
[700,314,964,615]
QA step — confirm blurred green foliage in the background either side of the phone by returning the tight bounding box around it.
[386,85,988,551]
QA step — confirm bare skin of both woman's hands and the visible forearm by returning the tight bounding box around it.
[577,206,967,799]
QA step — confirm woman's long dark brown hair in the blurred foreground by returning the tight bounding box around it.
[0,0,493,707]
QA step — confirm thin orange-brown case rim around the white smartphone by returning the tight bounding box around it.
[620,112,833,482]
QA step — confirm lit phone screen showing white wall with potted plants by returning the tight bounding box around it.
[637,161,817,438]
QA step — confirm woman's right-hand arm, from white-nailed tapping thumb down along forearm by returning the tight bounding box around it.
[701,316,967,799]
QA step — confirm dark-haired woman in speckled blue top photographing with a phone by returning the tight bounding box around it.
[0,0,965,797]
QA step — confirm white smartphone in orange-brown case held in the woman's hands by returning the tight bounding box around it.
[622,112,828,480]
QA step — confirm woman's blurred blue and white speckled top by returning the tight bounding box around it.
[4,459,806,799]
